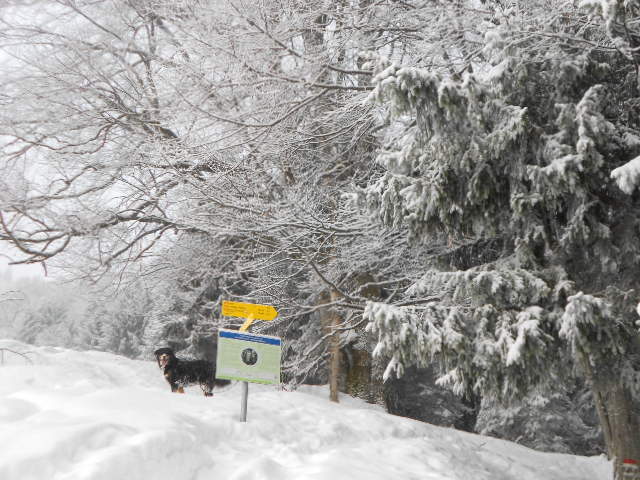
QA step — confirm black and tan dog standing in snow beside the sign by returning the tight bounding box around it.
[153,348,231,397]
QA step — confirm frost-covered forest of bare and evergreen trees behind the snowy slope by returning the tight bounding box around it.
[0,0,640,476]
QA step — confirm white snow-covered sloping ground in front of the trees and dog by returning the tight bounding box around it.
[0,341,611,480]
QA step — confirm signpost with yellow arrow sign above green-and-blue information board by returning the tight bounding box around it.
[216,301,282,422]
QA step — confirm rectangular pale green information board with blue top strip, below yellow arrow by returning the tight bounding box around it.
[216,329,282,384]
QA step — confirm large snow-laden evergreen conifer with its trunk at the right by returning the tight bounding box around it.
[363,1,640,476]
